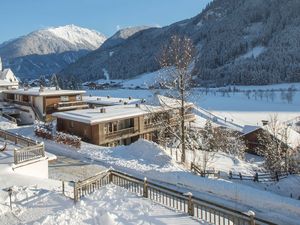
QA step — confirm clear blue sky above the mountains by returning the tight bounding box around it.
[0,0,211,43]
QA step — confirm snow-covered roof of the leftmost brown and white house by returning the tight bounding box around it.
[3,87,85,96]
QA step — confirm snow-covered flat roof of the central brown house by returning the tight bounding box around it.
[52,105,164,125]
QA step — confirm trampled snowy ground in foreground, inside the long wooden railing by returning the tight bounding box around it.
[0,185,205,225]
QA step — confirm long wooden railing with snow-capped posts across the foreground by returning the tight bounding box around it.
[74,170,273,225]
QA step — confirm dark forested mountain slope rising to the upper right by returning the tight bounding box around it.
[60,0,300,85]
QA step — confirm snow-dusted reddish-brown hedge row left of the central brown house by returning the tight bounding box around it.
[34,125,81,148]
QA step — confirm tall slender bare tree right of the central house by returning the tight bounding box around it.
[159,36,194,163]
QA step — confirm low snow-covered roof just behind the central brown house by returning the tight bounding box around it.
[83,96,142,105]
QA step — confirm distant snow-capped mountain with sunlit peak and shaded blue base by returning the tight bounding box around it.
[0,25,106,78]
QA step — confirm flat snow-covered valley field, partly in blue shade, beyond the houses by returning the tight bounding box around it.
[87,83,300,125]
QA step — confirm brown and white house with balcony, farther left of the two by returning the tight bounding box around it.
[2,86,88,124]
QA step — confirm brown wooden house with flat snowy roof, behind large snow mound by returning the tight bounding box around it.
[53,104,195,146]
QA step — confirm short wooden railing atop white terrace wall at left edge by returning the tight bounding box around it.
[0,129,45,165]
